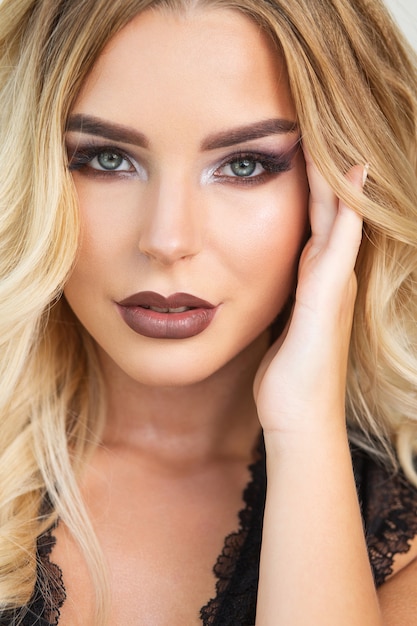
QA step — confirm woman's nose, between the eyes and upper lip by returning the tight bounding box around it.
[139,173,203,265]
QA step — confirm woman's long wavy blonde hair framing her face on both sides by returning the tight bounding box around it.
[0,0,417,624]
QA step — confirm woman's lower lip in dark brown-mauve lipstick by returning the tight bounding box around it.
[118,304,217,339]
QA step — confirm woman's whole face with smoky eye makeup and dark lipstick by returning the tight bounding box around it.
[65,10,308,385]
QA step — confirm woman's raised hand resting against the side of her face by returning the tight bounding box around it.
[254,153,366,432]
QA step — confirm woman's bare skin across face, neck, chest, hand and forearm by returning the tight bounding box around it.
[52,4,416,626]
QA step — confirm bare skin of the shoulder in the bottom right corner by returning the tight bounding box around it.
[378,536,417,626]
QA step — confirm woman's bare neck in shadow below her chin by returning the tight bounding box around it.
[97,333,268,462]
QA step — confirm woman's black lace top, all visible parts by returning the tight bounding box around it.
[0,443,417,626]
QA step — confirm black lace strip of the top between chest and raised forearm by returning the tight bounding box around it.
[200,437,266,626]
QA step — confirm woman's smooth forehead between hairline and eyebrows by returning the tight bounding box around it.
[70,8,294,139]
